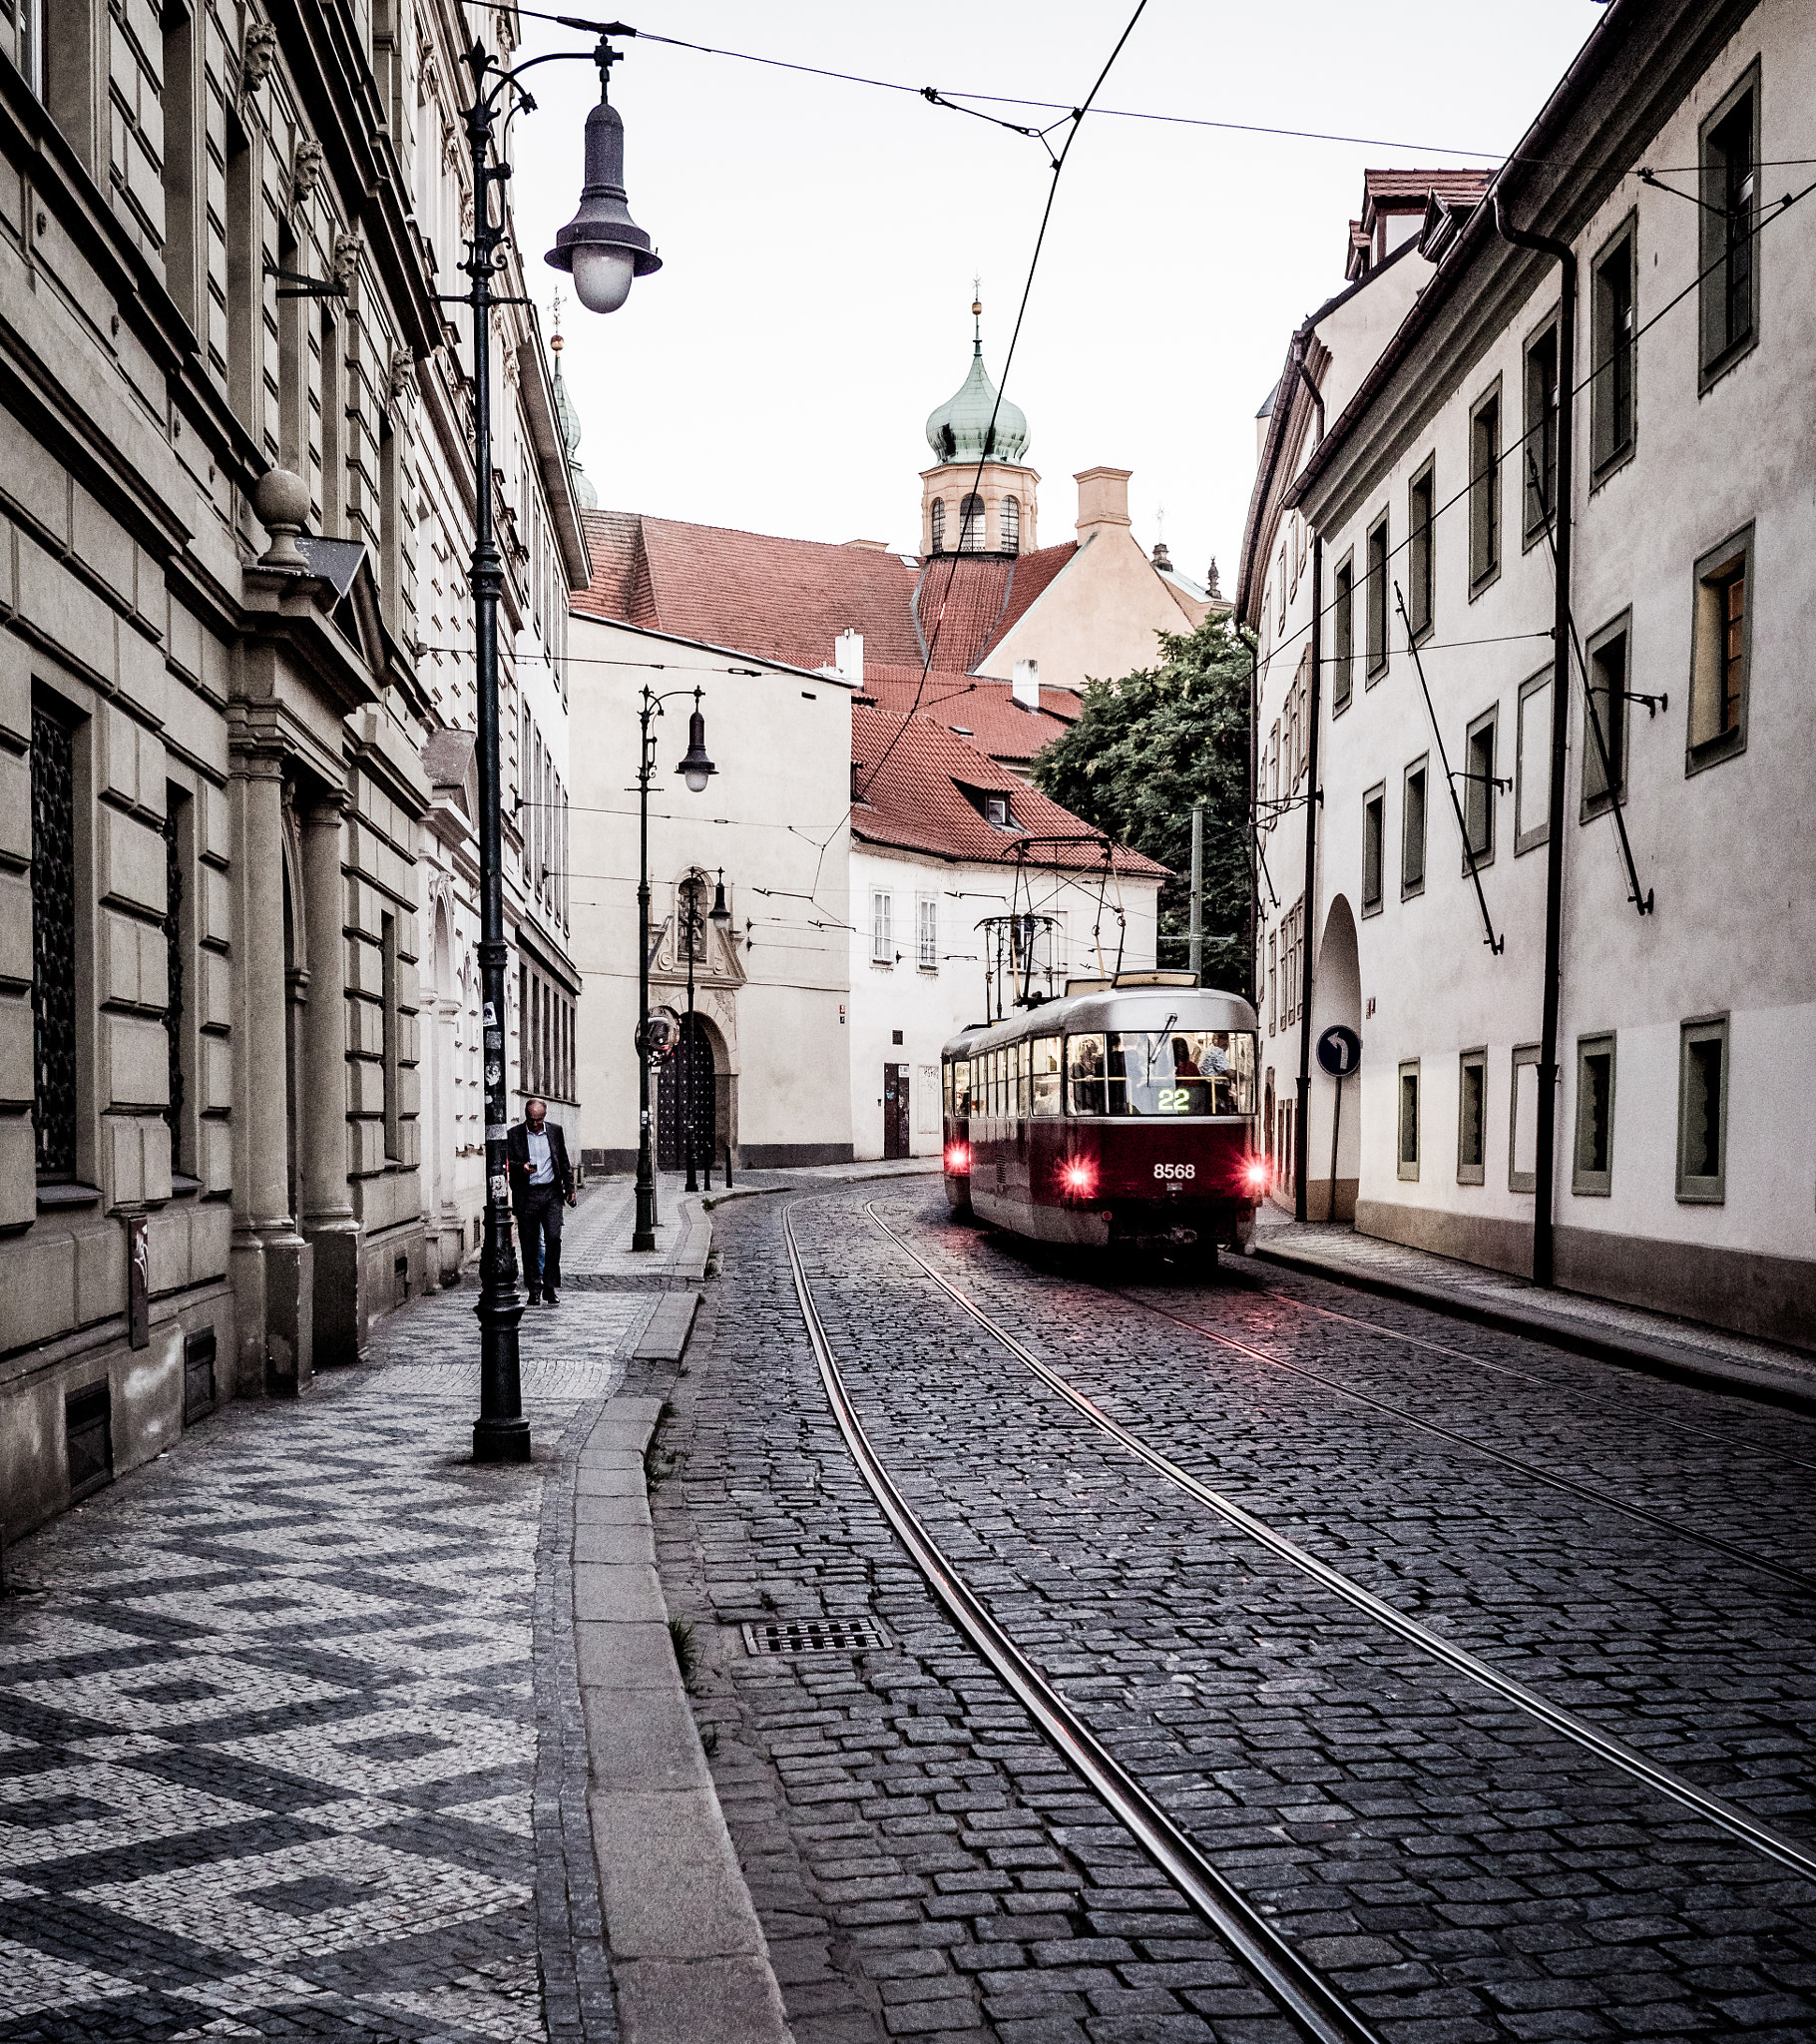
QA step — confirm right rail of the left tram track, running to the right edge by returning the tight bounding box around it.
[857,1200,1816,1882]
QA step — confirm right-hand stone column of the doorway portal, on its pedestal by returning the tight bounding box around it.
[300,789,365,1363]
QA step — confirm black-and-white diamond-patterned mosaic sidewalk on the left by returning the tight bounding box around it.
[0,1267,650,2044]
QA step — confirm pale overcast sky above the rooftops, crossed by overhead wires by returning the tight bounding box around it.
[511,0,1601,591]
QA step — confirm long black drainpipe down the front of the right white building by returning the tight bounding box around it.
[1496,193,1577,1285]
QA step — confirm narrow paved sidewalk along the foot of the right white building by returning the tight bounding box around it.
[1254,1210,1816,1412]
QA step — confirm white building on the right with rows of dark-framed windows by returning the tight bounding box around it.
[1285,0,1816,1343]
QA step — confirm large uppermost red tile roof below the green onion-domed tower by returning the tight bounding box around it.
[574,511,1077,675]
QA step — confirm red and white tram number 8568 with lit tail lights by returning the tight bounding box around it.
[942,973,1266,1258]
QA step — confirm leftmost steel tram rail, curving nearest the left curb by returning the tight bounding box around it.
[782,1200,1383,2044]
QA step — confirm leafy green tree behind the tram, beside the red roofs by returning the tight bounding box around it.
[1034,613,1252,995]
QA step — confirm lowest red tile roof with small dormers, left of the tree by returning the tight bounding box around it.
[852,704,1166,881]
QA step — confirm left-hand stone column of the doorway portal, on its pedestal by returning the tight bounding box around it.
[230,742,312,1396]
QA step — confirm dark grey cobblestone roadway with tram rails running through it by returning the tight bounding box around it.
[658,1188,1816,2044]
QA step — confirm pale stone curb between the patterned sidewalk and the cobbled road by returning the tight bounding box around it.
[572,1381,792,2044]
